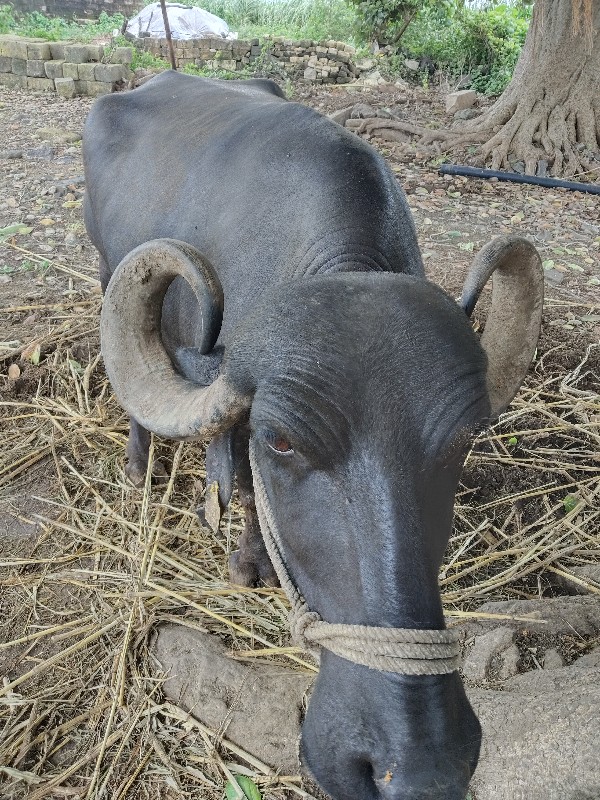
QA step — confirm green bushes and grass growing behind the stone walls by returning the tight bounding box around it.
[0,0,531,94]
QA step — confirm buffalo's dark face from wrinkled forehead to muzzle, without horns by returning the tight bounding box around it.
[225,276,489,800]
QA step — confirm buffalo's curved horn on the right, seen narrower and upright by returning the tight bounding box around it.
[460,236,544,417]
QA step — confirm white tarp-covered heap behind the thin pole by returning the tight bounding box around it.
[127,3,237,39]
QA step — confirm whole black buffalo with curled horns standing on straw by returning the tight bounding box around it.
[84,72,542,800]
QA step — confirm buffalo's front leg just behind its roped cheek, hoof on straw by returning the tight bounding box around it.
[229,425,279,586]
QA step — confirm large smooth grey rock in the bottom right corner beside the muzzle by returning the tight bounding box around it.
[467,664,600,800]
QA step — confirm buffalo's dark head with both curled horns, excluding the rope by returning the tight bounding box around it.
[102,238,543,800]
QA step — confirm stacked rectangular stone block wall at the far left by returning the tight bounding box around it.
[0,36,132,97]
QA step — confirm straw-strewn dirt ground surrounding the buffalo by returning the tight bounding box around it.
[0,76,600,800]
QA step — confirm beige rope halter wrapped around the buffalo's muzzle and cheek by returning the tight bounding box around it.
[250,441,460,675]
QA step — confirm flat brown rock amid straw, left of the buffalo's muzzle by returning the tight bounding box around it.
[152,625,313,775]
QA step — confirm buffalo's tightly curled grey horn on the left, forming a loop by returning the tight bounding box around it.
[100,239,250,439]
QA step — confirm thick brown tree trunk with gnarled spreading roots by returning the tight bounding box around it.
[462,0,600,180]
